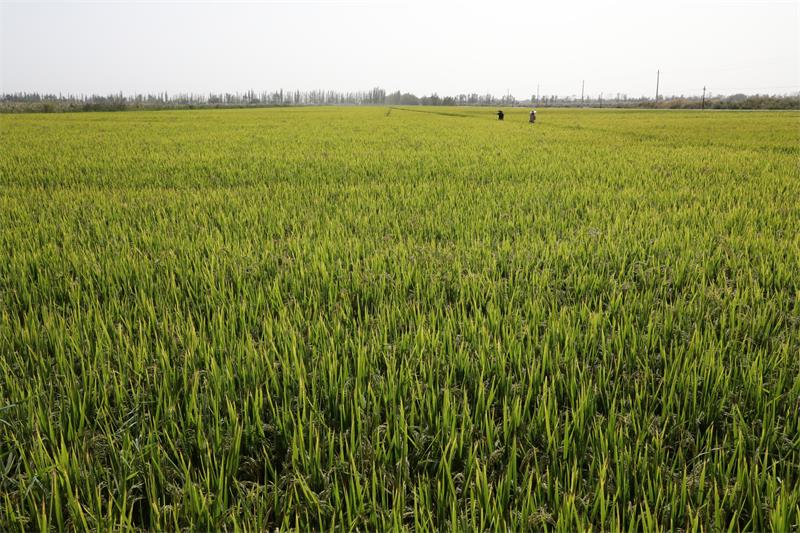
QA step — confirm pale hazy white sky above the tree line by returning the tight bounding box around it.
[0,0,800,98]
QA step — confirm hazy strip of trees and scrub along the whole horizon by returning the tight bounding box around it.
[0,87,800,113]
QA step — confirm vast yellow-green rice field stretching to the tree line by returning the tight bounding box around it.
[0,107,800,531]
